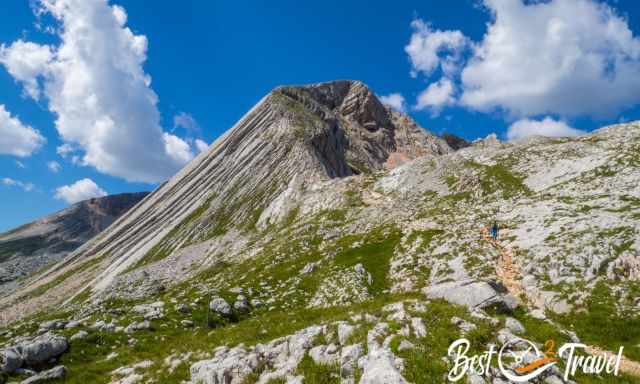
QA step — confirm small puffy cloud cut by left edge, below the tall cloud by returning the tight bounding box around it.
[0,104,46,157]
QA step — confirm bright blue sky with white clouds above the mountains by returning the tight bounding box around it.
[0,0,640,230]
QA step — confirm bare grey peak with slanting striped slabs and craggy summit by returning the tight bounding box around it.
[0,81,451,316]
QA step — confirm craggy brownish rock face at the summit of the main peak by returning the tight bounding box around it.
[273,81,451,176]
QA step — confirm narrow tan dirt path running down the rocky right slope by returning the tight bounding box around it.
[481,228,640,377]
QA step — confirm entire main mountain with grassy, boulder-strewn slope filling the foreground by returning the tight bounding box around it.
[0,81,640,384]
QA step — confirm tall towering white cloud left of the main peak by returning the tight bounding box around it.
[1,0,198,182]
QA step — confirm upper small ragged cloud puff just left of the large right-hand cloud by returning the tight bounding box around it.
[404,19,468,77]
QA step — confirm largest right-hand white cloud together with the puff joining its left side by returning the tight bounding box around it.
[405,0,640,118]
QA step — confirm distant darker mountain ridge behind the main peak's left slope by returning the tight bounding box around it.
[0,192,148,288]
